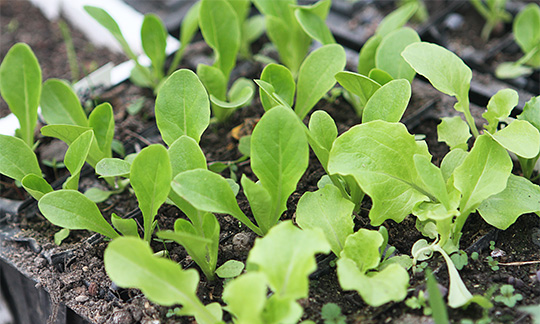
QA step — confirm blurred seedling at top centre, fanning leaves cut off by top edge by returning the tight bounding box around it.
[253,0,331,77]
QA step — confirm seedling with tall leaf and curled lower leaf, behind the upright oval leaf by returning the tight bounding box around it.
[197,0,255,122]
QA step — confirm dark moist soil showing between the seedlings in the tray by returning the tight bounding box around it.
[1,1,540,323]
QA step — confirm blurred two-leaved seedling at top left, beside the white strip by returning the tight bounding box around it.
[84,6,170,90]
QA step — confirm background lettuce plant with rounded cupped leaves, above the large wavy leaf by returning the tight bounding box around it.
[336,3,420,116]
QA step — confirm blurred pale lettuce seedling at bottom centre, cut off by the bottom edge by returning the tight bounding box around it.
[223,221,330,324]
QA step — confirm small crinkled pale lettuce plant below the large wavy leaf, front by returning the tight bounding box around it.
[296,184,410,306]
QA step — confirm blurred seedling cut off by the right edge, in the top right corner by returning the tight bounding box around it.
[495,3,540,79]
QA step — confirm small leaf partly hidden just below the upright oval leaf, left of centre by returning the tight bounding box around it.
[168,135,206,177]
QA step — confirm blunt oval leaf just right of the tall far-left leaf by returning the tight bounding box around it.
[40,79,88,127]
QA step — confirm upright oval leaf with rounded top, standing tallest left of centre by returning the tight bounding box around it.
[156,69,210,145]
